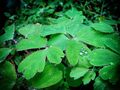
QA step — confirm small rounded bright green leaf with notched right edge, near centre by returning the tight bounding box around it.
[47,46,64,64]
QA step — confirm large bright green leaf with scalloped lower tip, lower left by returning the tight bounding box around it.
[18,50,46,79]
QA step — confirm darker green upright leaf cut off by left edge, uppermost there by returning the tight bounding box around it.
[0,24,15,43]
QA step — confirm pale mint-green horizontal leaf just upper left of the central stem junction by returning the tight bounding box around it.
[41,24,66,36]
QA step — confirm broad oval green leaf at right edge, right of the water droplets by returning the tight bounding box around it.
[89,49,120,66]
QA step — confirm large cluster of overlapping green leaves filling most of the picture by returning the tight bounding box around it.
[0,0,120,90]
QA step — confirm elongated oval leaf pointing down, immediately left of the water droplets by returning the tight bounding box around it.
[66,40,80,66]
